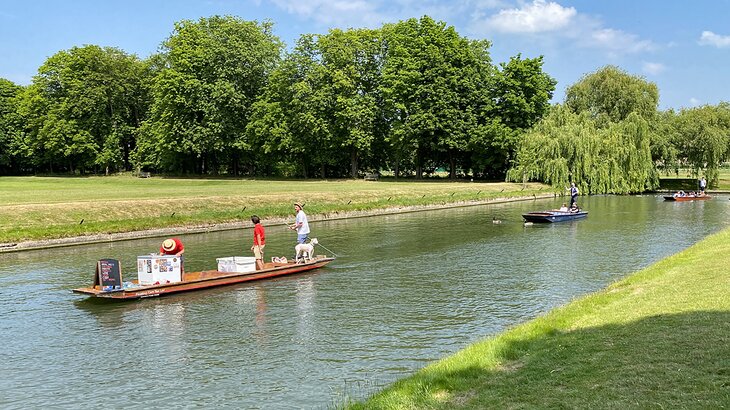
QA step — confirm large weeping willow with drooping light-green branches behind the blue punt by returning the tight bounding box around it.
[507,105,658,194]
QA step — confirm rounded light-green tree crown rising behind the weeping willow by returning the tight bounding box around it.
[565,66,659,124]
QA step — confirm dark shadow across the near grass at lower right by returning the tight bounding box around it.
[354,311,730,409]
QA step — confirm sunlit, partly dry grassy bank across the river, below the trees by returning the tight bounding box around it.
[0,176,550,243]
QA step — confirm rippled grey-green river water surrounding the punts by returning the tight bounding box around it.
[0,196,730,409]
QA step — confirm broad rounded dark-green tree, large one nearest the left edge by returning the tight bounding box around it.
[19,45,147,172]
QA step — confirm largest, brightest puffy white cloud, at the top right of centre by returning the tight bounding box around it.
[487,0,577,33]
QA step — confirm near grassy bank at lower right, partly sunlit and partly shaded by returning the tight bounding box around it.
[349,226,730,409]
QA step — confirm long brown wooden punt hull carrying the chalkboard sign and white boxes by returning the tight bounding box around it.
[72,255,335,300]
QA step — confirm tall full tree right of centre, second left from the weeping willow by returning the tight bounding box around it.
[381,16,487,178]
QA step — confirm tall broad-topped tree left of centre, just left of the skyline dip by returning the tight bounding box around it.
[138,16,283,174]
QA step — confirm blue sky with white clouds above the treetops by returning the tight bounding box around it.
[0,0,730,109]
